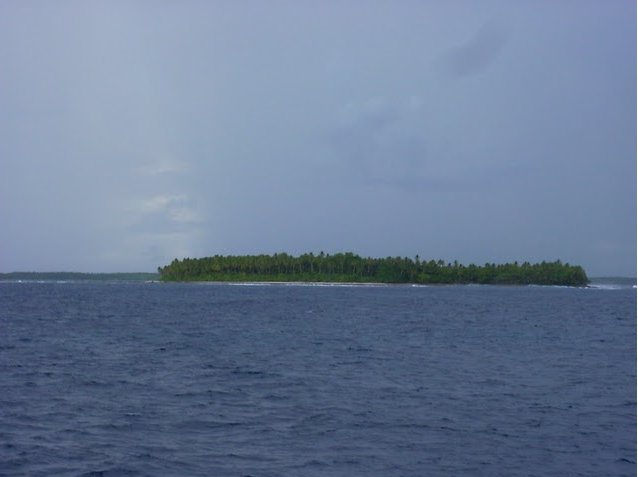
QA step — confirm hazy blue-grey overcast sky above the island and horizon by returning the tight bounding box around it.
[0,0,636,276]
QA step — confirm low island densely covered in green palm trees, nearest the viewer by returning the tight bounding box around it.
[158,252,589,287]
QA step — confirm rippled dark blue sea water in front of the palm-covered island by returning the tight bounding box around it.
[0,283,636,477]
